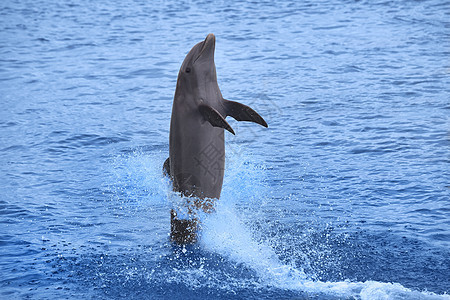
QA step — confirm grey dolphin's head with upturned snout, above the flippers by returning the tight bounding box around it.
[177,33,218,99]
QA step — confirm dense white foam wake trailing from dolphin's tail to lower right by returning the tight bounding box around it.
[200,199,450,300]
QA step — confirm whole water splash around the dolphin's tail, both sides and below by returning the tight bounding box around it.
[106,152,450,299]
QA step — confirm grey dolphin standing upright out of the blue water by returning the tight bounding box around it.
[163,33,267,244]
